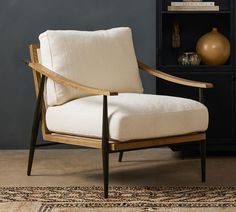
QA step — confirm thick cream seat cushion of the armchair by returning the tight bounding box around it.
[46,93,208,141]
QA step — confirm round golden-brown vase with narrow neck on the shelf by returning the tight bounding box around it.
[196,28,230,65]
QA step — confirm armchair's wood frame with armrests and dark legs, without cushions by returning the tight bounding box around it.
[27,44,213,198]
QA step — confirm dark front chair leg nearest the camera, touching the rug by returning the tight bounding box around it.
[102,96,109,198]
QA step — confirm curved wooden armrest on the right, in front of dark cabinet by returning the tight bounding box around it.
[138,61,213,88]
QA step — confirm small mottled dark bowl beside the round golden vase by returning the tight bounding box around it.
[178,52,201,66]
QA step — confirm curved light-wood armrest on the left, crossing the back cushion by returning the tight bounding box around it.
[26,62,118,96]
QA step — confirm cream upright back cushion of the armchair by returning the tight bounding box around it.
[39,27,143,106]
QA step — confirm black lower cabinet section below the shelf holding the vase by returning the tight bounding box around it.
[157,72,236,148]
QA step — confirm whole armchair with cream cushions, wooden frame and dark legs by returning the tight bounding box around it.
[24,27,213,198]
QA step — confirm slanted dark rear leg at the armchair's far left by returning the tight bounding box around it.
[27,76,45,176]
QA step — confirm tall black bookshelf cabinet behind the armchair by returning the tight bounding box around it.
[156,0,236,151]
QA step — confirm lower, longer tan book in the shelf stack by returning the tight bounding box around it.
[168,6,220,11]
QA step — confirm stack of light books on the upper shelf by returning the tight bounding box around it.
[168,0,220,11]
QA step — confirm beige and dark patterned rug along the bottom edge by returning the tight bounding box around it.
[0,187,236,212]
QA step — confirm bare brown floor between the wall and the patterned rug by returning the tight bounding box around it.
[0,148,236,186]
